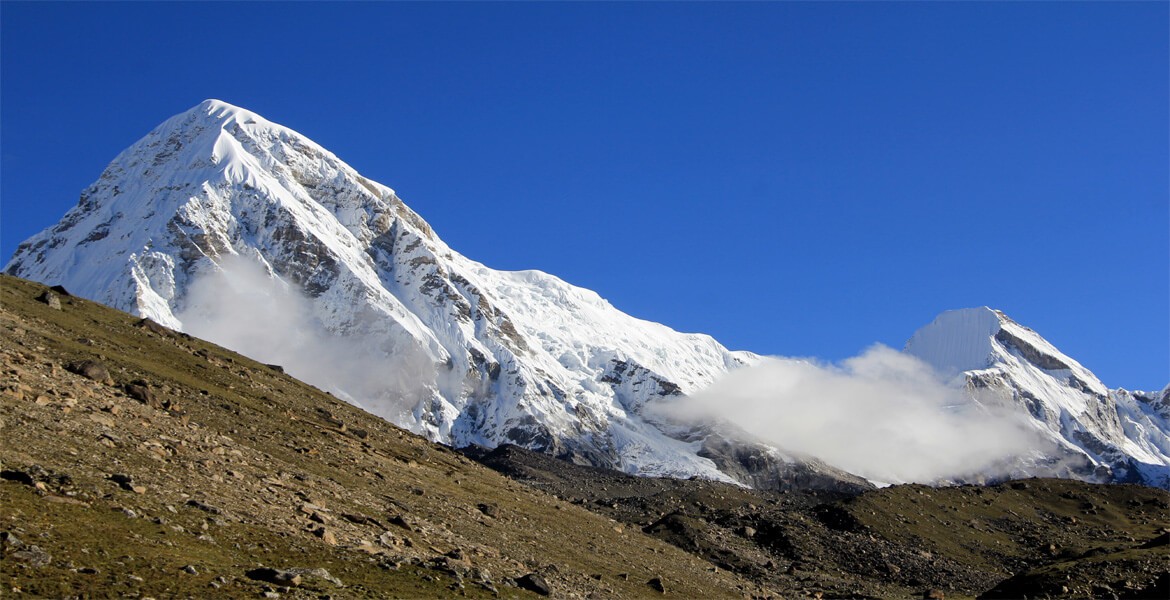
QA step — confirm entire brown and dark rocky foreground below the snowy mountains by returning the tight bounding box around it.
[0,276,1170,598]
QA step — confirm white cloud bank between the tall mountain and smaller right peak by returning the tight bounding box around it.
[654,345,1042,483]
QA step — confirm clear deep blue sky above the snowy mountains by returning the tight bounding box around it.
[0,1,1170,388]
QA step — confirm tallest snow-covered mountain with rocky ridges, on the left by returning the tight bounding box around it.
[6,101,865,487]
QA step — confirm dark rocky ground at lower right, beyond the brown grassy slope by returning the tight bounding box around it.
[469,447,1170,599]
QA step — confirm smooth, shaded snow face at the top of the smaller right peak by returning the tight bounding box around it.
[904,306,1007,374]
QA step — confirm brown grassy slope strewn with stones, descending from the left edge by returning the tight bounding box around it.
[0,276,771,598]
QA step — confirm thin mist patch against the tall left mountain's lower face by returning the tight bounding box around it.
[176,256,435,422]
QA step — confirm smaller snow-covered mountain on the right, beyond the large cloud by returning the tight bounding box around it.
[904,308,1170,488]
